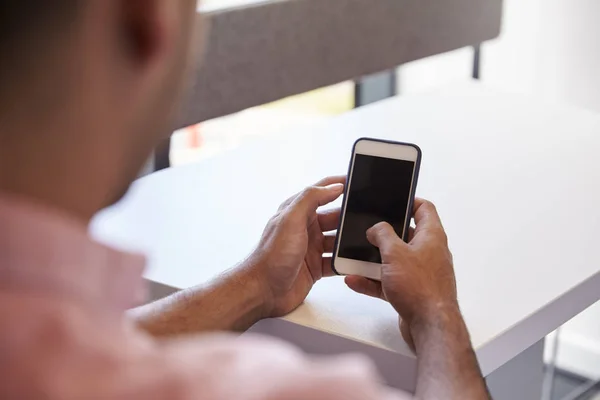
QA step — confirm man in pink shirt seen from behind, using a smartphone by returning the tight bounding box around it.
[0,0,488,400]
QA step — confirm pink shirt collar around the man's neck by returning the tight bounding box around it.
[0,195,145,312]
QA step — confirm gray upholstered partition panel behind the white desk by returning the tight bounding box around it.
[178,0,502,126]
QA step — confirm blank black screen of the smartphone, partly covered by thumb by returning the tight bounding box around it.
[338,154,415,264]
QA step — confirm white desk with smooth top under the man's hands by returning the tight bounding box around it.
[92,84,600,399]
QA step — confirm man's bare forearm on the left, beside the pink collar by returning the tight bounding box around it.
[131,265,265,337]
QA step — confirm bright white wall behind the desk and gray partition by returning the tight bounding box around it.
[399,0,600,378]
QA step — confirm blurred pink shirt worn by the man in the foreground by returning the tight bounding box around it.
[0,197,410,400]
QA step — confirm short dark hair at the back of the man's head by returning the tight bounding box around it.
[0,0,80,101]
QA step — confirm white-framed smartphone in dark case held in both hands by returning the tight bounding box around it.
[332,138,421,280]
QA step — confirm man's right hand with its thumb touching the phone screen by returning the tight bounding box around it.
[346,199,460,349]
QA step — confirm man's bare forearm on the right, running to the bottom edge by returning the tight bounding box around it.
[411,306,490,400]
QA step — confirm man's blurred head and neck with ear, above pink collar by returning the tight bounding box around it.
[0,0,200,219]
